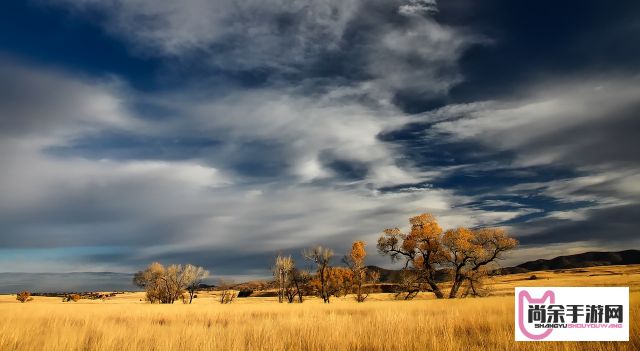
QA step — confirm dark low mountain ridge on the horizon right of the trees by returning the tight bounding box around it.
[498,250,640,274]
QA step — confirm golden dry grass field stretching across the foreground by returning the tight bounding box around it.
[0,265,640,351]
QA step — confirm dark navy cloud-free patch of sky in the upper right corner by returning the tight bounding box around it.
[437,0,640,102]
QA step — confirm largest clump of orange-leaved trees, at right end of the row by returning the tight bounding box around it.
[378,213,518,299]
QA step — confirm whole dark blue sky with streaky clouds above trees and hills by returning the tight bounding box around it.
[0,0,640,279]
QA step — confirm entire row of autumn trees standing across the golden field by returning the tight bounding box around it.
[127,213,518,303]
